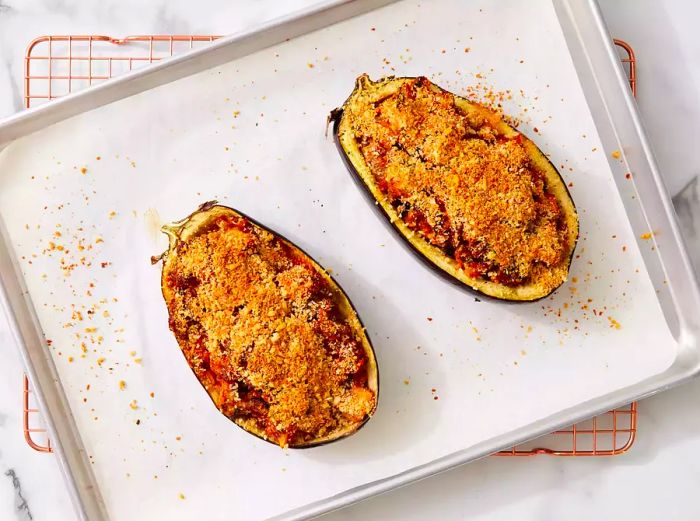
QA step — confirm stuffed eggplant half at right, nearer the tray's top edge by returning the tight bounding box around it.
[331,75,578,301]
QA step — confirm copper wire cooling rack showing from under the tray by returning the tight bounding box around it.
[22,35,637,456]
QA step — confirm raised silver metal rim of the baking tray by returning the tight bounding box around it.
[0,0,700,520]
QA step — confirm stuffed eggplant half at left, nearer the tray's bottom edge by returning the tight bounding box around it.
[153,203,379,447]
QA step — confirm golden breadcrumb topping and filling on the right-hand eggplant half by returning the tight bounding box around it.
[343,78,569,288]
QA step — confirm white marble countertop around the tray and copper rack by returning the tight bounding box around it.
[0,0,700,521]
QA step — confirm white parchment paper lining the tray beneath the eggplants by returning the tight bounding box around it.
[0,1,675,519]
